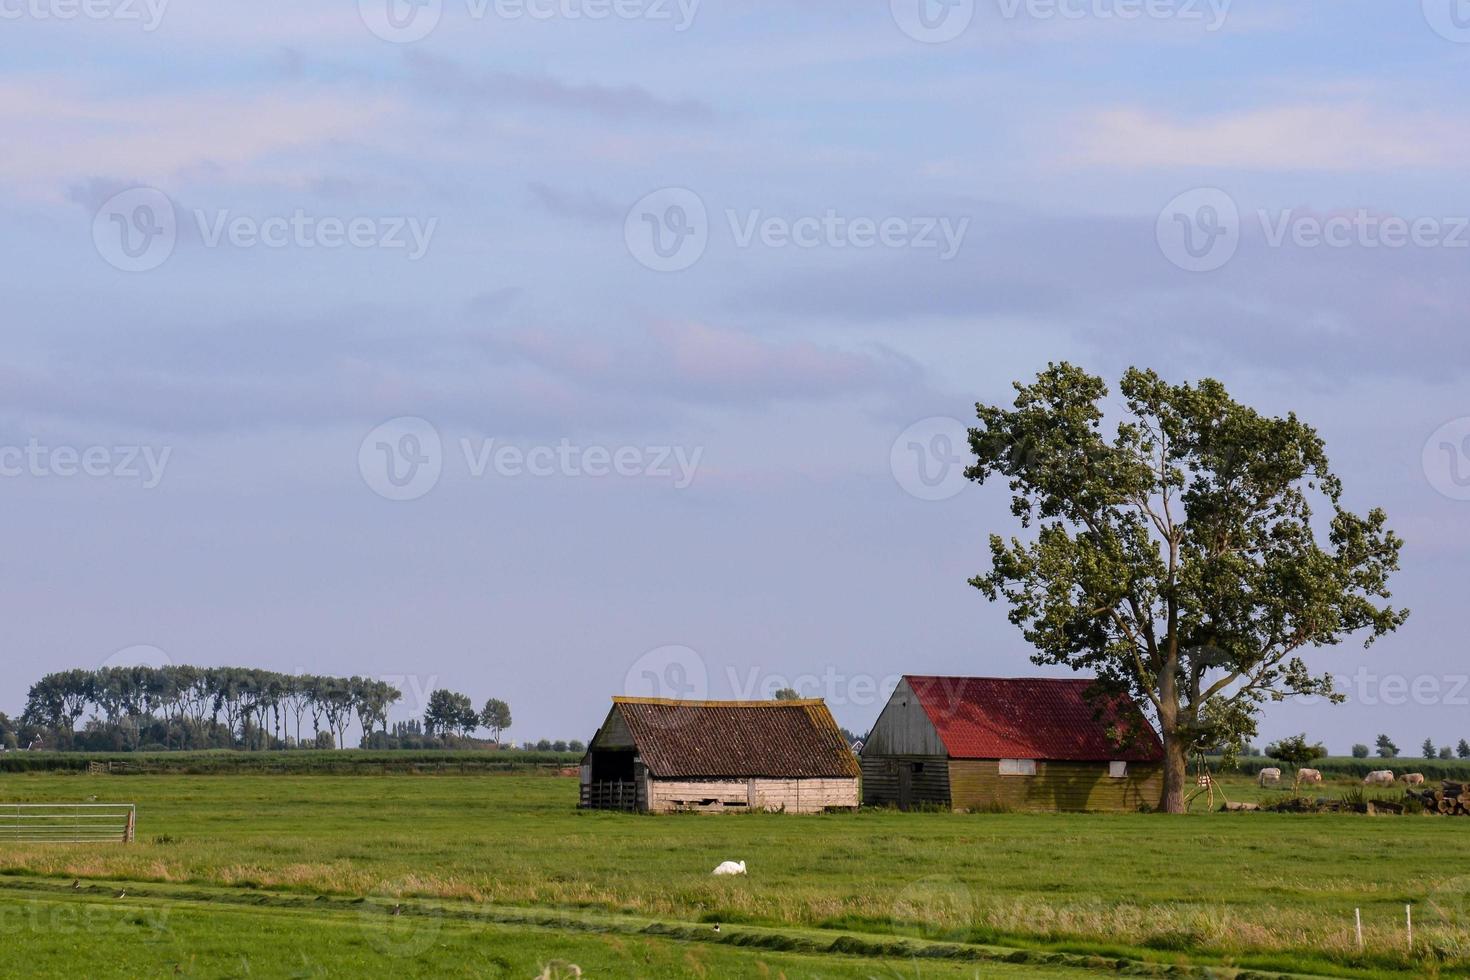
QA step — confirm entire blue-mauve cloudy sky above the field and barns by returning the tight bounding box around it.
[0,0,1470,752]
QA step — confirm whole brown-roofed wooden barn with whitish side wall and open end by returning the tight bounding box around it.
[581,698,860,813]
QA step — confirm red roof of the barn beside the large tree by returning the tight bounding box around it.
[904,676,1164,763]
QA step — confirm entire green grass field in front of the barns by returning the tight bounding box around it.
[0,773,1470,977]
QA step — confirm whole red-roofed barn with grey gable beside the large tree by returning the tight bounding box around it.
[861,676,1164,811]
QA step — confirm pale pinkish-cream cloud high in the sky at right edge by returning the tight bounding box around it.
[1069,103,1470,172]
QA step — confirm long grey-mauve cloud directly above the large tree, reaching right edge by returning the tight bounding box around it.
[728,200,1470,383]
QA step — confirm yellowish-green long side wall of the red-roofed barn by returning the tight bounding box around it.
[950,760,1164,811]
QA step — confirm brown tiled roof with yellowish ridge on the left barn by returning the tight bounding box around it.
[613,698,858,779]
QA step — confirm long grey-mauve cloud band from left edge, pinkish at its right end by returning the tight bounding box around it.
[0,310,920,435]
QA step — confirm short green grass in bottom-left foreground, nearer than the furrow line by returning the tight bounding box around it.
[0,896,1111,980]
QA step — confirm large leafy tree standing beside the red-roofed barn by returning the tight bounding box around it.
[967,363,1408,813]
